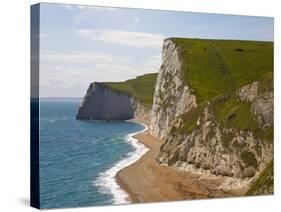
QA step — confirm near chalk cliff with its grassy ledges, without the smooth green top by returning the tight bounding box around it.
[150,39,273,182]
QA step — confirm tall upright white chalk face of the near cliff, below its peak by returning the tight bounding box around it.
[150,39,196,139]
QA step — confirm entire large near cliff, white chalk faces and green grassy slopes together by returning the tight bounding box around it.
[150,38,273,193]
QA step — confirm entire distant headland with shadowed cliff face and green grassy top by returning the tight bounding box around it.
[76,74,156,123]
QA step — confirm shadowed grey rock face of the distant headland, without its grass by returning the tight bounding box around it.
[76,82,151,122]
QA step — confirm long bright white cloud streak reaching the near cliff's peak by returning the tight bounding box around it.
[76,29,164,48]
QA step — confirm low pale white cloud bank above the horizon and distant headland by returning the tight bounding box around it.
[40,51,161,97]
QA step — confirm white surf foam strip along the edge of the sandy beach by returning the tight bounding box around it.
[94,124,148,204]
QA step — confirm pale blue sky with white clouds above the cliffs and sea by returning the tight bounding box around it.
[40,3,274,97]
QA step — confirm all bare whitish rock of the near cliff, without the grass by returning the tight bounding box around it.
[149,39,273,181]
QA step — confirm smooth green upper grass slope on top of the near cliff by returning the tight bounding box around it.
[171,38,273,104]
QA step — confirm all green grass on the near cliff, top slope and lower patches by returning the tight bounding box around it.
[172,38,273,147]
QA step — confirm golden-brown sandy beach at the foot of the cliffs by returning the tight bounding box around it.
[116,132,242,203]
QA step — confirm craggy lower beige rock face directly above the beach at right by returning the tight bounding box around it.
[157,82,273,178]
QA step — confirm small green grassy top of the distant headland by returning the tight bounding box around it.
[101,73,157,107]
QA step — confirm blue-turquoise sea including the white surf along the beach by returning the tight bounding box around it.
[39,99,148,208]
